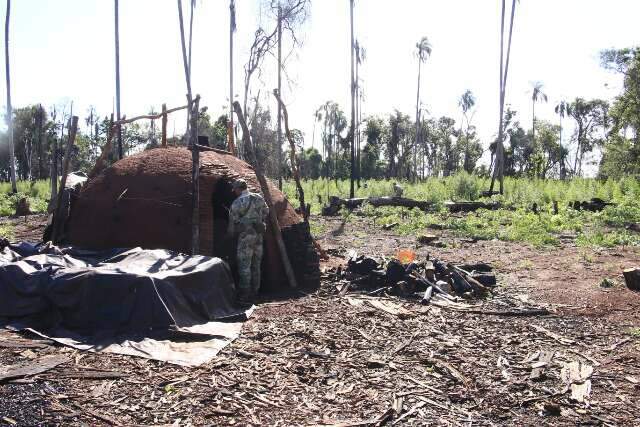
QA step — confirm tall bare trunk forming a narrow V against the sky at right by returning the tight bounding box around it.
[489,0,516,194]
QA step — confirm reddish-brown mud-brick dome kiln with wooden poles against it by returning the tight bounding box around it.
[65,147,319,290]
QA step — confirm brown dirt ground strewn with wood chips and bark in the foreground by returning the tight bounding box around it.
[0,218,640,426]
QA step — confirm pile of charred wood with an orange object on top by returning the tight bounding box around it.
[333,250,496,304]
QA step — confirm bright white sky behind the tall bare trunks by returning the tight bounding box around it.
[0,0,640,170]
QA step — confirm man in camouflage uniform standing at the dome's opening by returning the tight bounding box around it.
[229,179,269,304]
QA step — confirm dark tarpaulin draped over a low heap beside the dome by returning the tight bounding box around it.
[0,243,249,366]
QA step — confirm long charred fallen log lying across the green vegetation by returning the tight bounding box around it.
[323,196,501,216]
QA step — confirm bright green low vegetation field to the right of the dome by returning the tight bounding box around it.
[284,172,640,247]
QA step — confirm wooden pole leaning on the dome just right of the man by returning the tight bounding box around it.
[233,101,298,289]
